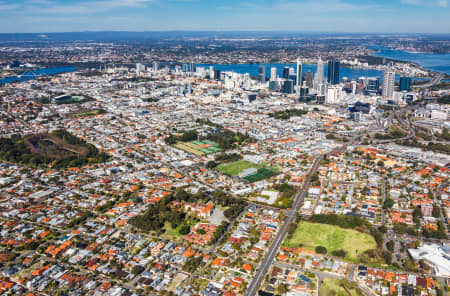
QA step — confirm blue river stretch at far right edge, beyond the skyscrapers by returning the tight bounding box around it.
[370,45,450,75]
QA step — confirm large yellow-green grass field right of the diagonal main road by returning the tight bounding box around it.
[285,221,377,262]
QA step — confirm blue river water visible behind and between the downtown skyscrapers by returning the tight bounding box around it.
[196,64,436,81]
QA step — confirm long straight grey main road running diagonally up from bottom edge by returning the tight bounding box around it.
[245,156,322,296]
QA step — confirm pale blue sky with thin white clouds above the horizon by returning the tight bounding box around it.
[0,0,450,33]
